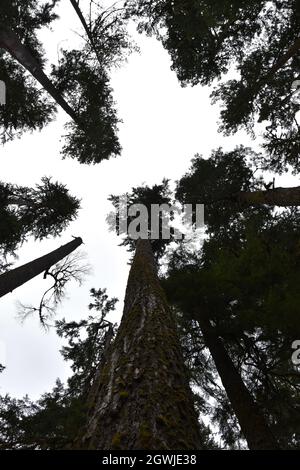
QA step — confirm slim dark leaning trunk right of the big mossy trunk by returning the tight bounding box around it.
[197,314,279,450]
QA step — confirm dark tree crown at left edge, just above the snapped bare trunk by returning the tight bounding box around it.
[0,177,80,253]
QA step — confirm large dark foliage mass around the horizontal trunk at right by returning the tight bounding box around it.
[169,149,300,448]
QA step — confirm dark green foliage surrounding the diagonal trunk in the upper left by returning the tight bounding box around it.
[0,0,134,164]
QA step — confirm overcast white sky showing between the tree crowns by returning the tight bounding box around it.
[0,1,299,398]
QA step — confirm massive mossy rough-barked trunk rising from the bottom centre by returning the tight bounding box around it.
[74,240,201,450]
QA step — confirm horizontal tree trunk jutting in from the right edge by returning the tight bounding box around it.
[237,186,300,207]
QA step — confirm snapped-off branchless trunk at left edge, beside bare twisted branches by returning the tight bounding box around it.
[0,238,83,297]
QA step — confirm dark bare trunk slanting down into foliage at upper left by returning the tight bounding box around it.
[0,28,82,127]
